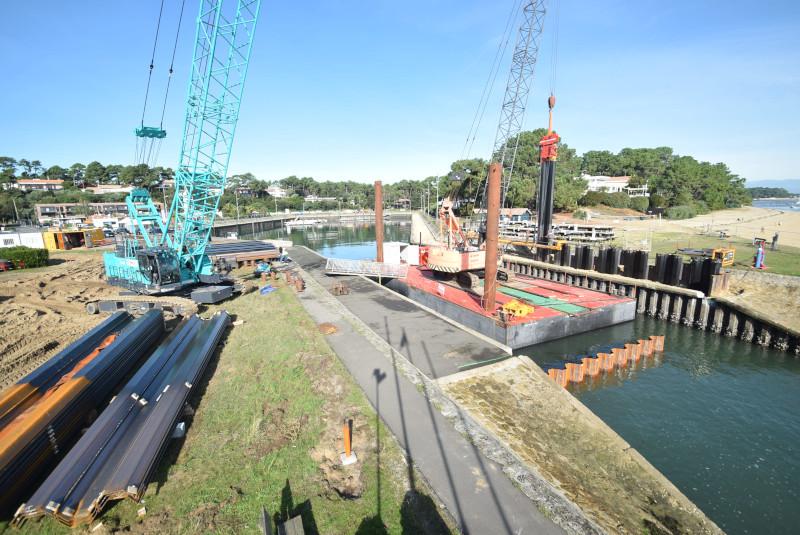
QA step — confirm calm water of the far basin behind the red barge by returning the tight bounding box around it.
[239,221,411,260]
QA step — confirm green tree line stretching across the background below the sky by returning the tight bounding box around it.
[0,134,751,224]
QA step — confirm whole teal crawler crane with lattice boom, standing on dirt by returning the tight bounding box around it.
[87,0,261,314]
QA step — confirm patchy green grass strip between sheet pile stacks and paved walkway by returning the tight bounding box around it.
[10,278,452,534]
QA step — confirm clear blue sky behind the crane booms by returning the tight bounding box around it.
[0,0,800,182]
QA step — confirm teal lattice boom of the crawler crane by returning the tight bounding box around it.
[168,0,261,276]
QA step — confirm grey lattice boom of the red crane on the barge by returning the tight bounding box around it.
[483,0,547,208]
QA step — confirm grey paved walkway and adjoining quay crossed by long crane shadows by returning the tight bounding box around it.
[289,247,564,535]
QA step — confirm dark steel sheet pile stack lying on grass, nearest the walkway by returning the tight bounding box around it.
[12,312,229,527]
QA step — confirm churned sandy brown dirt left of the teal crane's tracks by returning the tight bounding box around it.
[0,254,118,390]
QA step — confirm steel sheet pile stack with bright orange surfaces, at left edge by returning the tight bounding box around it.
[0,310,164,511]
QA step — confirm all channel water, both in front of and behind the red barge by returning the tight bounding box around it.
[247,223,800,535]
